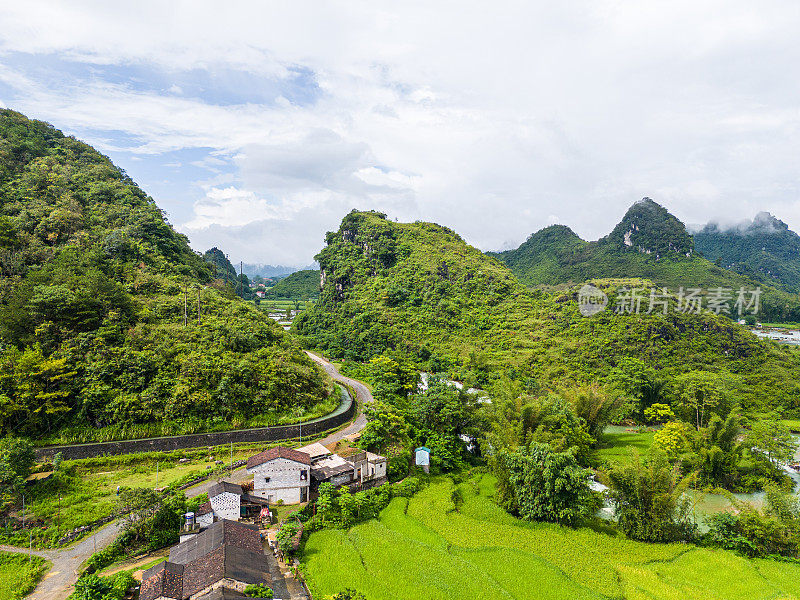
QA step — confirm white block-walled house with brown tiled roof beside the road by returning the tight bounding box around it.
[247,446,311,504]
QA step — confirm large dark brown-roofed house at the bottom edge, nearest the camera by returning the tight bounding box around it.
[139,520,280,600]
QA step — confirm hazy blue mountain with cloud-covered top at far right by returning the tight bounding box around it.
[694,212,800,293]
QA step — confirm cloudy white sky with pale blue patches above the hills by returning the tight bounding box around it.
[0,0,800,266]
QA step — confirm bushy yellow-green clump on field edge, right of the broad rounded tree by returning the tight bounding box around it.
[603,449,696,542]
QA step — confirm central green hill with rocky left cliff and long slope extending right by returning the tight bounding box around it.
[294,211,800,408]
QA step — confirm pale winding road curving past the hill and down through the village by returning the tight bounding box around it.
[8,351,373,600]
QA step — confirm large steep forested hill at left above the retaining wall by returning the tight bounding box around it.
[0,110,329,441]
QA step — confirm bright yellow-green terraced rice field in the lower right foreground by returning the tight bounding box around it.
[303,476,800,600]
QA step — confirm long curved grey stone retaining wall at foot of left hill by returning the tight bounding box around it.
[35,389,357,460]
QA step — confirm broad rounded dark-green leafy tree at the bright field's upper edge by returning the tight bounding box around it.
[493,443,595,525]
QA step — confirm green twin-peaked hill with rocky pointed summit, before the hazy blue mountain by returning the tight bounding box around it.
[489,198,800,321]
